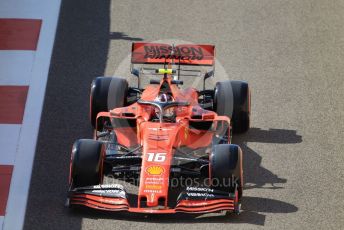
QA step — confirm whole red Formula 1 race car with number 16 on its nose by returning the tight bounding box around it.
[67,43,250,213]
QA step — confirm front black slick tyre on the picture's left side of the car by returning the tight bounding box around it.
[70,139,103,187]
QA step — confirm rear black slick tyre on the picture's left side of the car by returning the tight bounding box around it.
[90,77,128,128]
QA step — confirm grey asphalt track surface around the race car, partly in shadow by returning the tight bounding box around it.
[25,0,344,230]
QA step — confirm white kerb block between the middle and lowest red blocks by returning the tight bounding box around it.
[0,124,21,165]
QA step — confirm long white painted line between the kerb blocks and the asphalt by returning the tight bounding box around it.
[0,0,61,230]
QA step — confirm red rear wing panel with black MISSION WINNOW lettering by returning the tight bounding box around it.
[131,42,215,66]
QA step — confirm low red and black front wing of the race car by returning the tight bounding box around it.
[67,184,240,213]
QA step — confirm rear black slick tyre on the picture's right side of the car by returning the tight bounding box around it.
[214,80,251,133]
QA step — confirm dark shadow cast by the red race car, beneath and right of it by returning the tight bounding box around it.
[66,128,302,226]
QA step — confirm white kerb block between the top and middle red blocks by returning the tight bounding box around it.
[0,50,35,85]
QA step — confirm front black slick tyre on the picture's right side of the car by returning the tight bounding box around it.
[210,144,243,199]
